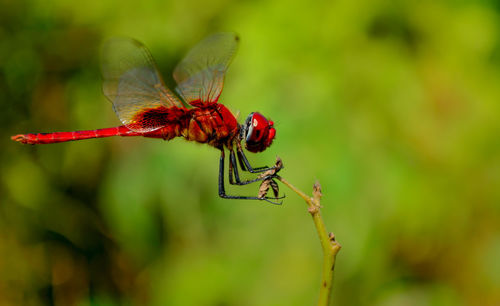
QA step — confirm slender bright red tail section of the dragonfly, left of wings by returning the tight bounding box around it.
[11,126,144,144]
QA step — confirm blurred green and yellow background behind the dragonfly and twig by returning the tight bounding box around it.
[0,0,500,306]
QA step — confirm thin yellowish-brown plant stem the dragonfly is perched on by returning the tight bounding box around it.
[276,176,341,306]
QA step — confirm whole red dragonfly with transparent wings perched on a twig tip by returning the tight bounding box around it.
[11,33,284,203]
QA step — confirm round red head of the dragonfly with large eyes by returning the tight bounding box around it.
[242,112,276,153]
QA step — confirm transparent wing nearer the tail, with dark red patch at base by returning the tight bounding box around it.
[101,38,184,132]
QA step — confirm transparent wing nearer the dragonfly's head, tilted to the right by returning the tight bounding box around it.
[174,33,239,103]
